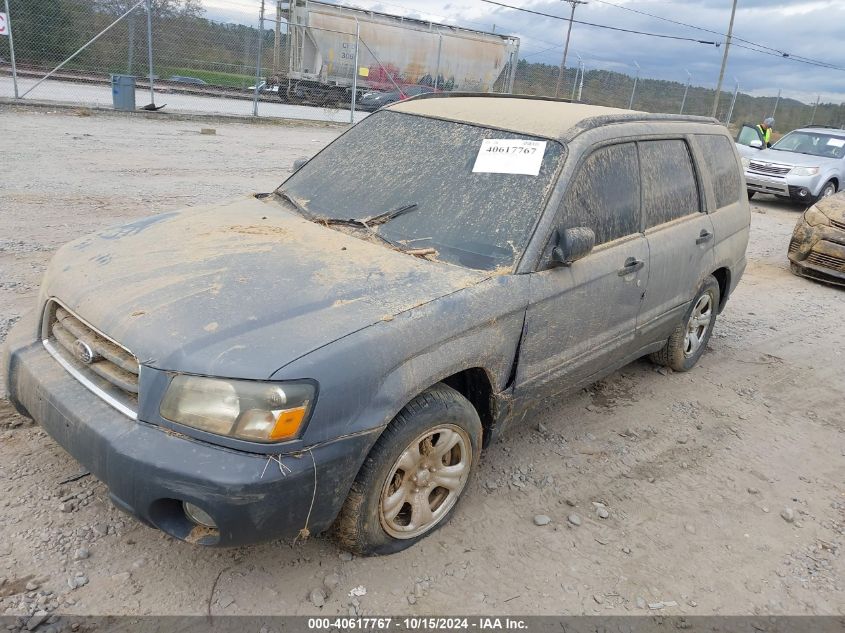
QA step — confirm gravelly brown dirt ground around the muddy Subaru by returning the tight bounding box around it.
[0,107,845,615]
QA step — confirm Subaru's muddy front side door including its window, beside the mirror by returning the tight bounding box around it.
[516,143,648,398]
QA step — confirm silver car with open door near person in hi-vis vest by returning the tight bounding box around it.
[736,124,845,205]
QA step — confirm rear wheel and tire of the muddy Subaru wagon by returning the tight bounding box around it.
[650,275,721,371]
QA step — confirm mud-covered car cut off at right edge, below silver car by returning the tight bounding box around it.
[788,192,845,286]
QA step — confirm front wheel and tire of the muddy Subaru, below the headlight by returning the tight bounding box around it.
[331,384,482,556]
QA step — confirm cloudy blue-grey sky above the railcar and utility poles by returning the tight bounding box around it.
[204,0,845,103]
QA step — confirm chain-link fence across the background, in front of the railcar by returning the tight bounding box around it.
[0,0,845,132]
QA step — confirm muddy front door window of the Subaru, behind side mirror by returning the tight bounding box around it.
[560,143,640,245]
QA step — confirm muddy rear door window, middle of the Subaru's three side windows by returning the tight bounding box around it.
[639,140,700,228]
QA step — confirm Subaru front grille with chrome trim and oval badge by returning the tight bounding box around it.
[43,300,139,418]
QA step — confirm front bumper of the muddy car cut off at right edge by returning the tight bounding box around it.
[787,219,845,286]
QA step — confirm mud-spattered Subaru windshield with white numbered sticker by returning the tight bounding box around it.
[277,110,563,270]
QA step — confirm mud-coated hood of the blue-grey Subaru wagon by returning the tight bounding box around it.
[43,196,491,379]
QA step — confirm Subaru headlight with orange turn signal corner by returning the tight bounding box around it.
[161,375,315,442]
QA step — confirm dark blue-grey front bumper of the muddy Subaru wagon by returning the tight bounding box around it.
[5,314,375,546]
